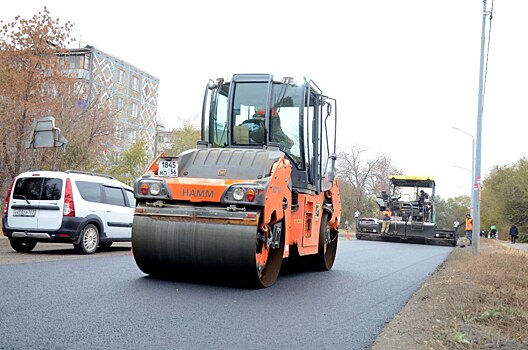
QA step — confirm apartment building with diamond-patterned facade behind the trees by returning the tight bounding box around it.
[63,46,159,159]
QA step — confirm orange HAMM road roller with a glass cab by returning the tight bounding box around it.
[132,74,341,288]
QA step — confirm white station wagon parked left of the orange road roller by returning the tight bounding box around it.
[2,170,135,254]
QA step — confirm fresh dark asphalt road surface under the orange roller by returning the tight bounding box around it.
[0,239,453,349]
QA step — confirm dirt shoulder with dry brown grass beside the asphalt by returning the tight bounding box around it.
[372,239,528,350]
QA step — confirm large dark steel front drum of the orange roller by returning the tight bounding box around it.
[132,215,284,287]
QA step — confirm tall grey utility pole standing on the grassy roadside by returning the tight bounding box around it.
[472,0,490,255]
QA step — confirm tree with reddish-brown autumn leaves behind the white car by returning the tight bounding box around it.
[0,8,113,194]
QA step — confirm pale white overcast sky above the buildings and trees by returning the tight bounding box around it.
[0,0,528,198]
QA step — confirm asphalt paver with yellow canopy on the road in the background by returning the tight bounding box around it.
[356,175,458,246]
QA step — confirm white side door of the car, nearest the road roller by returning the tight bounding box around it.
[103,185,133,239]
